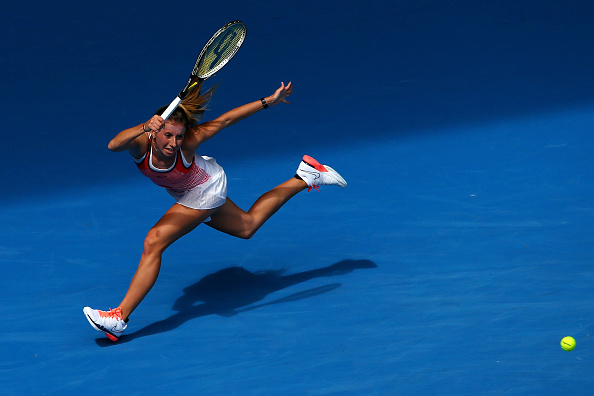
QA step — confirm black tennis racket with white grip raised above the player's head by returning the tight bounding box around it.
[161,21,247,120]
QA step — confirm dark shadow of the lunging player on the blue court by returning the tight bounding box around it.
[96,260,377,346]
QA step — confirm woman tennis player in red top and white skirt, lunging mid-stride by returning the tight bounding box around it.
[83,83,347,342]
